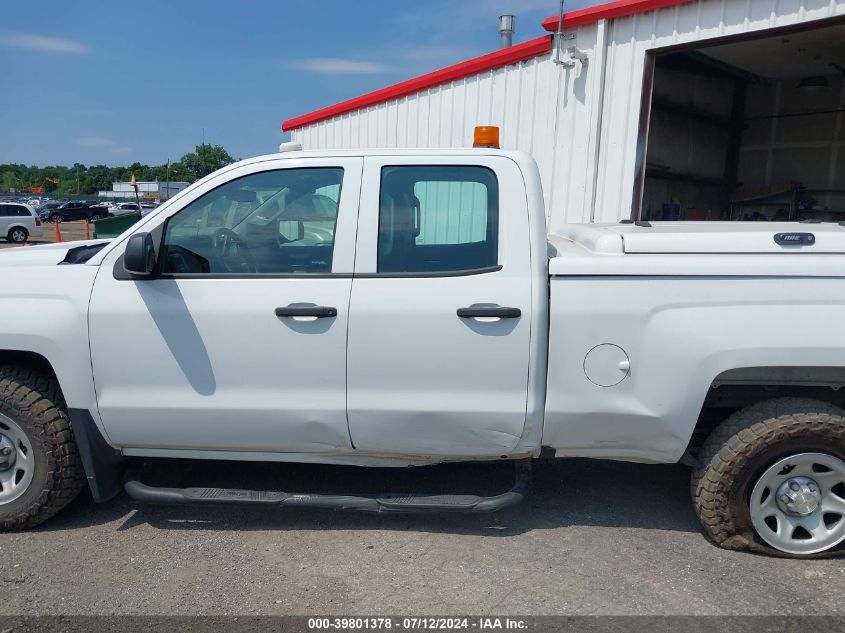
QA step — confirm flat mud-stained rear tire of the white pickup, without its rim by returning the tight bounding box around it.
[691,398,845,558]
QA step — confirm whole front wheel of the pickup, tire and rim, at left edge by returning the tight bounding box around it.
[0,367,85,530]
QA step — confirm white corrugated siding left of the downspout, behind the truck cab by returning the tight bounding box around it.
[293,37,597,230]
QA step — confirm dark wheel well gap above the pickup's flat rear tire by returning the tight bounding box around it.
[687,367,845,455]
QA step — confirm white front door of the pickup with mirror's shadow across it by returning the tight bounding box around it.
[90,157,362,454]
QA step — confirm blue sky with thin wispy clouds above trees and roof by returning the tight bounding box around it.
[0,0,597,166]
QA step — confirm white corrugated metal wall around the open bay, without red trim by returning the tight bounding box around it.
[293,0,845,231]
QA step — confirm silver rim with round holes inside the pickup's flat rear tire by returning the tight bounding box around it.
[749,453,845,554]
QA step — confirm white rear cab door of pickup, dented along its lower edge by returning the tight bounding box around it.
[347,155,532,456]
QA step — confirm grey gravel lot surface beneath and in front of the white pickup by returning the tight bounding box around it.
[0,460,845,615]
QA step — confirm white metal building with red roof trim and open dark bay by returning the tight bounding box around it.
[282,0,845,232]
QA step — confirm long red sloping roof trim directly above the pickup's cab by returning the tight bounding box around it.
[282,35,552,132]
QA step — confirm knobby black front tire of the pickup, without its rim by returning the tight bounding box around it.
[0,366,85,531]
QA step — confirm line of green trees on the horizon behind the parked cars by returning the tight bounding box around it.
[0,144,235,196]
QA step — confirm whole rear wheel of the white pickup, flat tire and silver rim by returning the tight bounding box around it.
[692,398,845,557]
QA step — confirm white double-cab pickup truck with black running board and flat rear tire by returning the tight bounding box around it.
[0,149,845,556]
